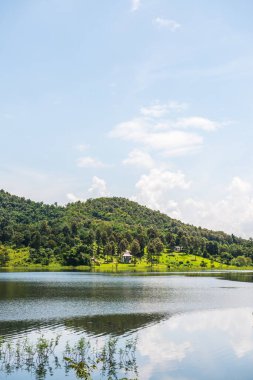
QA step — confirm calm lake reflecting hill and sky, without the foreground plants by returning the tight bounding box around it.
[0,272,253,380]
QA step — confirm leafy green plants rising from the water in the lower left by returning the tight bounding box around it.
[0,336,138,380]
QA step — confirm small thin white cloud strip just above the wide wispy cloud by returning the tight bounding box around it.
[140,101,187,117]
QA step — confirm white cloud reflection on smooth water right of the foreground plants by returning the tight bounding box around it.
[138,308,253,379]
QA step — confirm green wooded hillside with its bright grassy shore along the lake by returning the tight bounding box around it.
[0,190,253,272]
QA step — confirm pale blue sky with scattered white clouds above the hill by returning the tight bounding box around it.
[0,0,253,237]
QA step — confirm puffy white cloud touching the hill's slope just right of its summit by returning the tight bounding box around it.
[133,168,190,217]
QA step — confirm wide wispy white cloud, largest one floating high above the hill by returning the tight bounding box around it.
[109,102,224,157]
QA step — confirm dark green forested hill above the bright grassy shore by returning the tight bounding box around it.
[0,190,253,265]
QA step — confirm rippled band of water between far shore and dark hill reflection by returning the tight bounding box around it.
[0,273,252,325]
